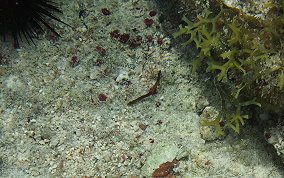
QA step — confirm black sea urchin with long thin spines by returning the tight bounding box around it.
[0,0,69,46]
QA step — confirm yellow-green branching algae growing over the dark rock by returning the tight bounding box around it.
[173,1,284,135]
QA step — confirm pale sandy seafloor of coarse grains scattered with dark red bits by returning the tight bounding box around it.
[0,0,284,177]
